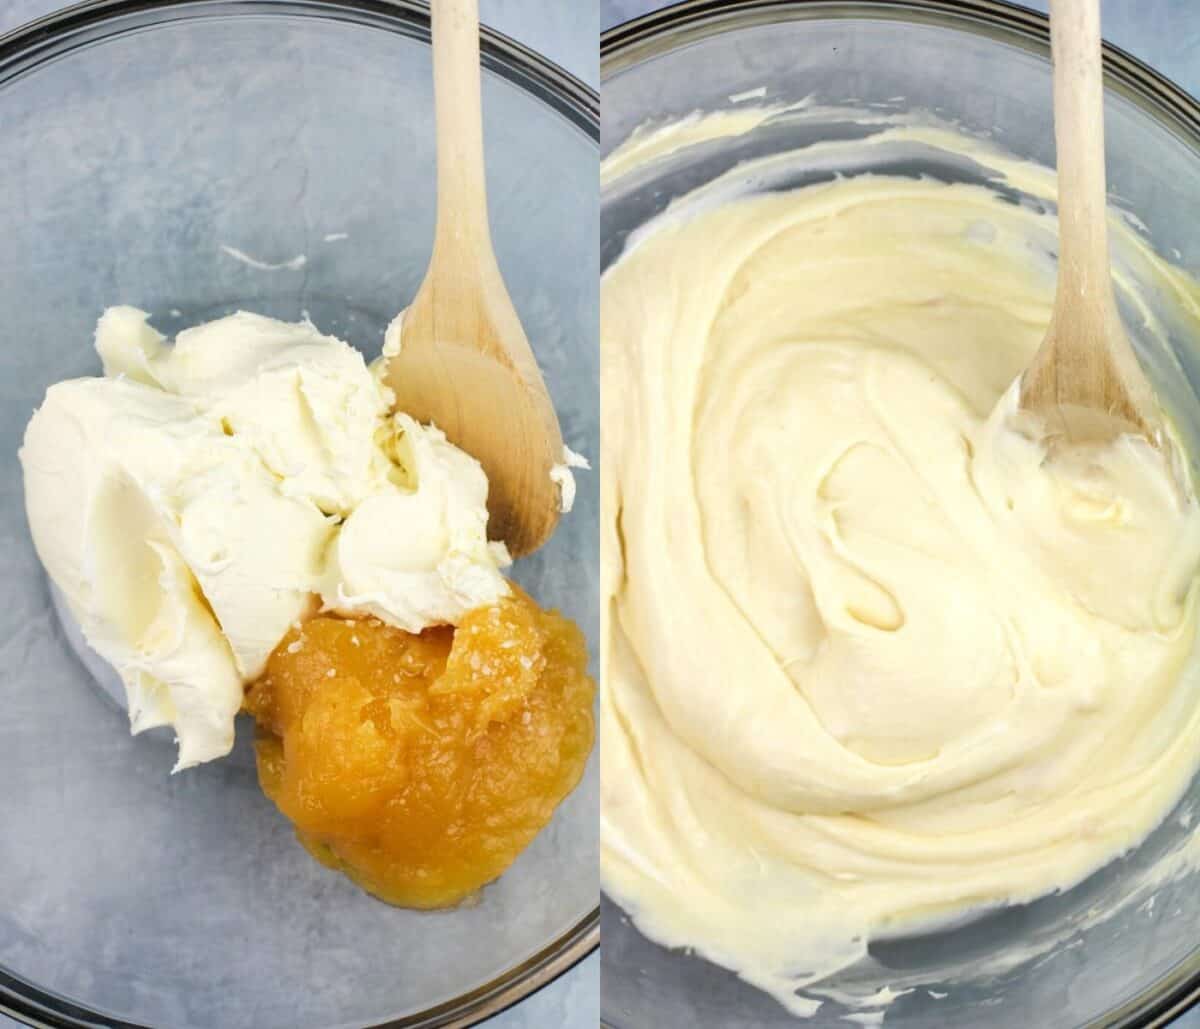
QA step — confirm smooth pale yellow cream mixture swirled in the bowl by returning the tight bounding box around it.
[601,126,1200,1013]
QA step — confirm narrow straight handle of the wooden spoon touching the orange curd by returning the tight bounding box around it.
[432,0,491,258]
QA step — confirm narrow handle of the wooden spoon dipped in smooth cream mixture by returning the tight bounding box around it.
[1050,0,1112,331]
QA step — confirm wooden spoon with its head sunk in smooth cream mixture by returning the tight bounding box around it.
[1020,0,1165,446]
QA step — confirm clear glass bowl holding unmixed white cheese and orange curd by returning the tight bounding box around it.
[0,0,599,1029]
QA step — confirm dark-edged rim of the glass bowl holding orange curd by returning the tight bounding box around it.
[0,0,600,1029]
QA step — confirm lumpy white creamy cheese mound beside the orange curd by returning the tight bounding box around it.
[20,307,508,770]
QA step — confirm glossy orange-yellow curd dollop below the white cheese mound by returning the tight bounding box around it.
[245,588,594,908]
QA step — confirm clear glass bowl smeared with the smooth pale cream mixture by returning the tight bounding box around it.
[600,0,1200,1029]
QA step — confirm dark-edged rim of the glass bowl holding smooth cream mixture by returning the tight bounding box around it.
[600,0,1200,1029]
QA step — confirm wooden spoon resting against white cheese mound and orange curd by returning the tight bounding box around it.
[388,0,563,556]
